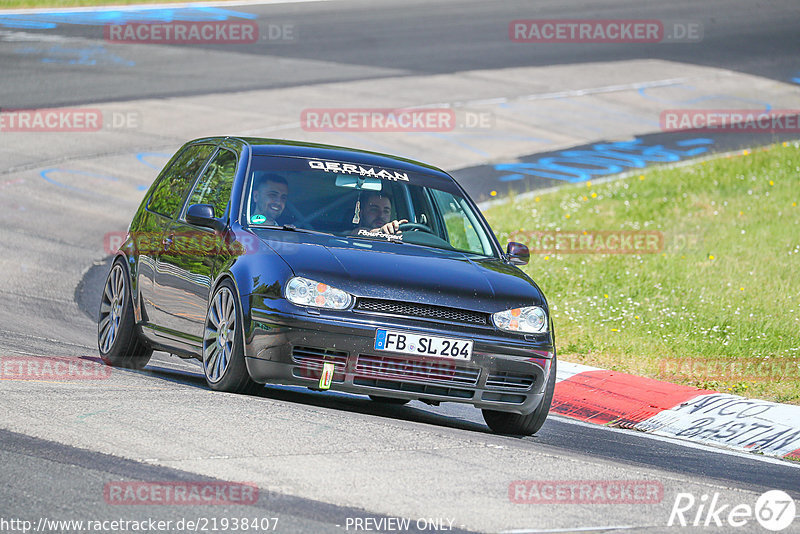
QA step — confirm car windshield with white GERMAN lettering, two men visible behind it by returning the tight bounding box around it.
[242,156,497,257]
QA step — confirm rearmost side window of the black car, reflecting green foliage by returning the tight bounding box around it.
[147,145,214,219]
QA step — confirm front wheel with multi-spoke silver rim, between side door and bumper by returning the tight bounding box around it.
[203,280,261,394]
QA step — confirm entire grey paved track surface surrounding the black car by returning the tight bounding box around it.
[0,0,800,533]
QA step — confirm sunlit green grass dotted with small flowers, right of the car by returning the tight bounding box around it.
[486,142,800,404]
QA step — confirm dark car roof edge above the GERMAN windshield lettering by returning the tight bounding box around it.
[192,137,455,182]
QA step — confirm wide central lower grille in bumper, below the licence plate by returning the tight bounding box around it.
[356,354,480,386]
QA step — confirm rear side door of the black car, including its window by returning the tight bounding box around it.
[138,144,214,336]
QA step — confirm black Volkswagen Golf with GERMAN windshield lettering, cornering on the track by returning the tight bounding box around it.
[98,137,556,435]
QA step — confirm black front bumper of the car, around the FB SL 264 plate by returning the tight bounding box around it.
[245,305,555,414]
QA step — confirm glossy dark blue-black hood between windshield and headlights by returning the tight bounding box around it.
[253,230,546,313]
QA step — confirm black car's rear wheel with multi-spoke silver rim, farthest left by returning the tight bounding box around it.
[97,259,153,369]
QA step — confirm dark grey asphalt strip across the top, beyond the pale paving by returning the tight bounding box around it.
[0,0,800,108]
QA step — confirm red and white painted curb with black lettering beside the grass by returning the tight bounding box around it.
[551,361,800,460]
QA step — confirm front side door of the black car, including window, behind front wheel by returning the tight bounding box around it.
[151,149,237,346]
